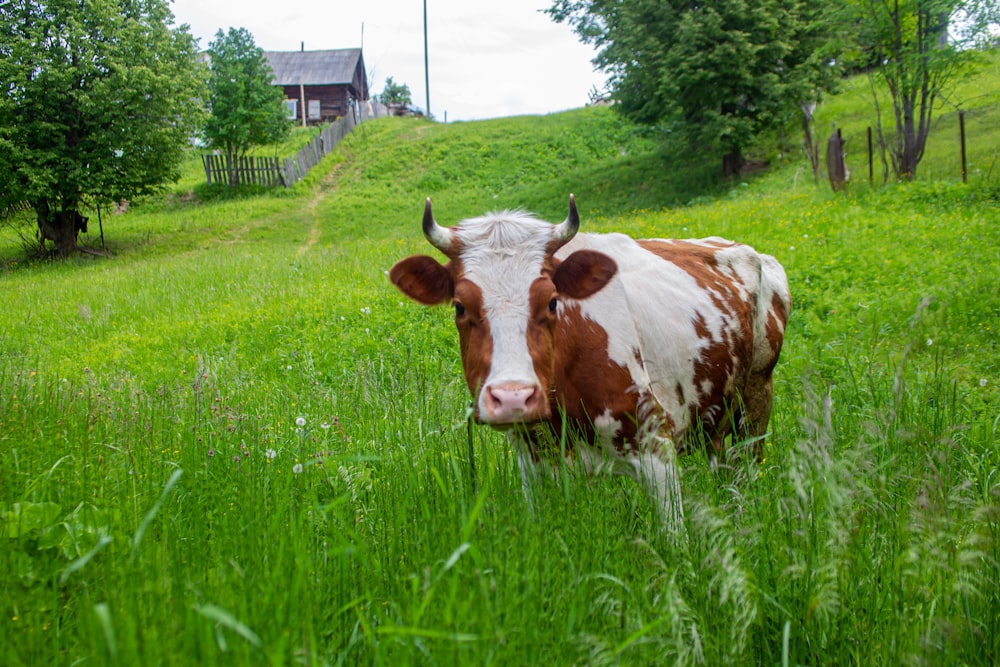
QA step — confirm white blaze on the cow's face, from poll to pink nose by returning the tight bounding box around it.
[455,211,553,423]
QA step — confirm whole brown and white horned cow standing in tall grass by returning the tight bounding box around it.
[389,195,791,524]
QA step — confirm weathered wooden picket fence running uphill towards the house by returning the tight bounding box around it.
[202,103,388,188]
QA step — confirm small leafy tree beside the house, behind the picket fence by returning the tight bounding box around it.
[204,28,290,185]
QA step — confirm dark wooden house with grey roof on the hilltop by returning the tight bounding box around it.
[264,48,368,125]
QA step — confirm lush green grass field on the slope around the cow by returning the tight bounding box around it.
[0,53,1000,666]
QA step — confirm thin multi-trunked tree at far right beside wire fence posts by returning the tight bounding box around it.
[842,0,998,180]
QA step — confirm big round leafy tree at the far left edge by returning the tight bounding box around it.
[0,0,204,256]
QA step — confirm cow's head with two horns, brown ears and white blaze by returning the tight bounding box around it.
[389,195,618,427]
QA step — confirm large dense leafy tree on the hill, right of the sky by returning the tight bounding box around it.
[547,0,835,173]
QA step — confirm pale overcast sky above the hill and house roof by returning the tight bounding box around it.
[171,0,606,121]
